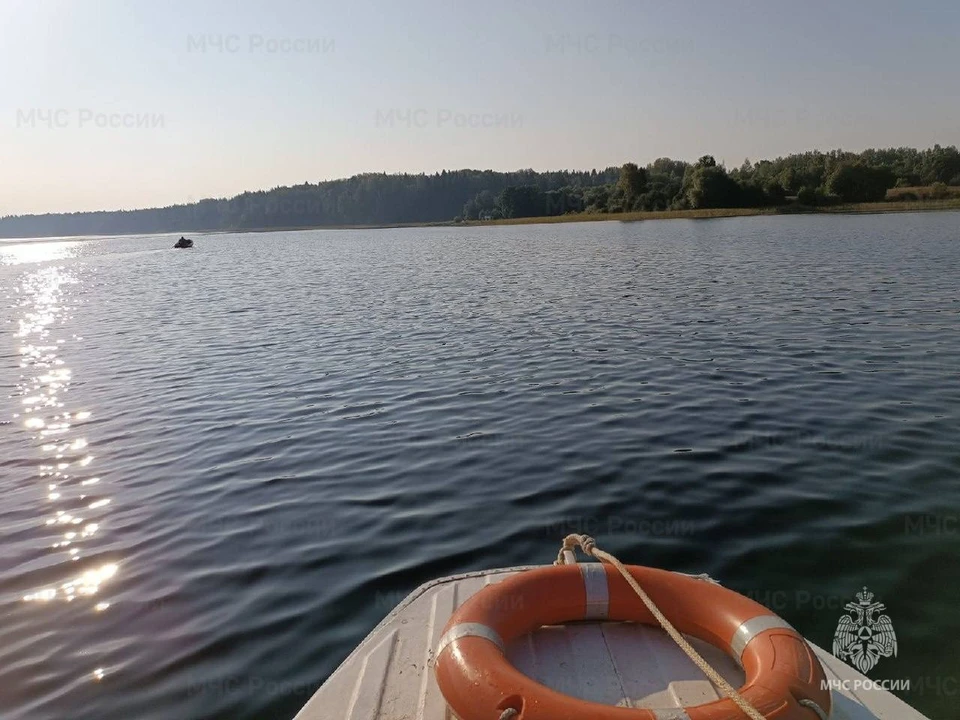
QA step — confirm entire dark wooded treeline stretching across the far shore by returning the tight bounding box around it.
[0,145,960,237]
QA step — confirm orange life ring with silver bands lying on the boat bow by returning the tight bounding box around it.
[435,562,830,720]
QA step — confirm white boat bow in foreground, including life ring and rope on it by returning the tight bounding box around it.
[294,536,928,720]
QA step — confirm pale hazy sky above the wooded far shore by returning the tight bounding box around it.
[0,0,960,215]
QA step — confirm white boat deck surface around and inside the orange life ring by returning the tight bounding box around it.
[295,568,927,720]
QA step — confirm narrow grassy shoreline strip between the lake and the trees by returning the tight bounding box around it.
[0,197,960,243]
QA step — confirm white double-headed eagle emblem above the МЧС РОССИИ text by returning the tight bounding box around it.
[833,587,897,673]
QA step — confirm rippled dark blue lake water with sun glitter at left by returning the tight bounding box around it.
[0,213,960,720]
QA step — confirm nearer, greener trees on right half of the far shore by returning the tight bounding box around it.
[459,145,960,220]
